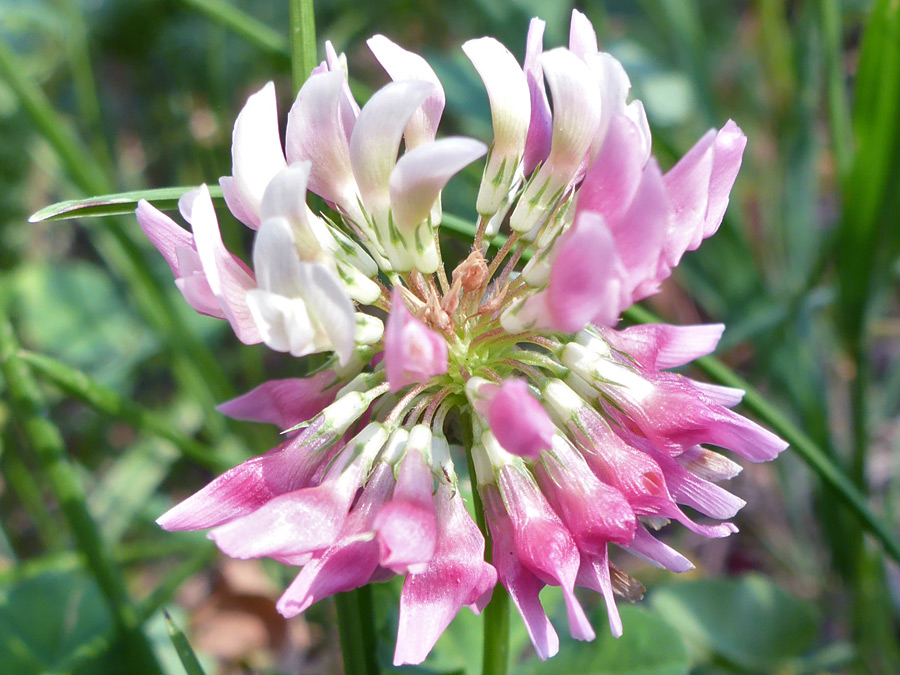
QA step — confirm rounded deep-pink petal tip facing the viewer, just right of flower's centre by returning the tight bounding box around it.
[488,378,556,457]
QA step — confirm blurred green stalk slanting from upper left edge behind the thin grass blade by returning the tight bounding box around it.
[0,40,232,428]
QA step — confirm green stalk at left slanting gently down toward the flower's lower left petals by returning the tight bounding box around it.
[19,349,231,471]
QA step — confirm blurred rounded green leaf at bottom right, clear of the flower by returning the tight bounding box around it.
[650,574,818,672]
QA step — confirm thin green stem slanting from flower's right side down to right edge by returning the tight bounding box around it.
[625,305,900,563]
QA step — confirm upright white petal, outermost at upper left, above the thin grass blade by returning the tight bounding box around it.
[231,82,287,225]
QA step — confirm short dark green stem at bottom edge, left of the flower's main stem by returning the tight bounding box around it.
[334,586,379,675]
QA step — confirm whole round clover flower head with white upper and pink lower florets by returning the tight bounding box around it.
[137,11,786,665]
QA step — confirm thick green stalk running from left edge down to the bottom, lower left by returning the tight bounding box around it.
[0,308,162,673]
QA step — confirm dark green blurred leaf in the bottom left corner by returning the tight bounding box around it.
[0,571,112,675]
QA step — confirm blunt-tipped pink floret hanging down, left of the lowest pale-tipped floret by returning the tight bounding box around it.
[373,448,437,574]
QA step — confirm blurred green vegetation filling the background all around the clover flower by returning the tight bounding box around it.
[0,0,900,674]
